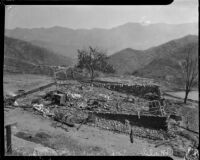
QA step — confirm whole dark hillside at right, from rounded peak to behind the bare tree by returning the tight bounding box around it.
[109,35,198,85]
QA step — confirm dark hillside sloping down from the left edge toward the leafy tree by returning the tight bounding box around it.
[4,37,71,73]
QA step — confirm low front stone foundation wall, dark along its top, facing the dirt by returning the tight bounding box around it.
[89,113,167,140]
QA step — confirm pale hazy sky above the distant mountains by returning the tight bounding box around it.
[5,0,198,29]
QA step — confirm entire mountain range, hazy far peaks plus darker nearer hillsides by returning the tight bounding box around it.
[4,23,198,86]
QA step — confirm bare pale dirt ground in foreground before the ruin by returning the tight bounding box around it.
[5,108,183,159]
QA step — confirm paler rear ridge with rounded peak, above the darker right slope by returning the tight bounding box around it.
[109,35,198,74]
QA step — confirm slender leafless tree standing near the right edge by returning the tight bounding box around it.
[181,45,198,103]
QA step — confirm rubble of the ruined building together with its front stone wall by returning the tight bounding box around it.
[10,79,181,139]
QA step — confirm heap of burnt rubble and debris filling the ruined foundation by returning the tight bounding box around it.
[17,83,166,127]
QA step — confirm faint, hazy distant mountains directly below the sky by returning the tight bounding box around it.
[5,23,198,58]
